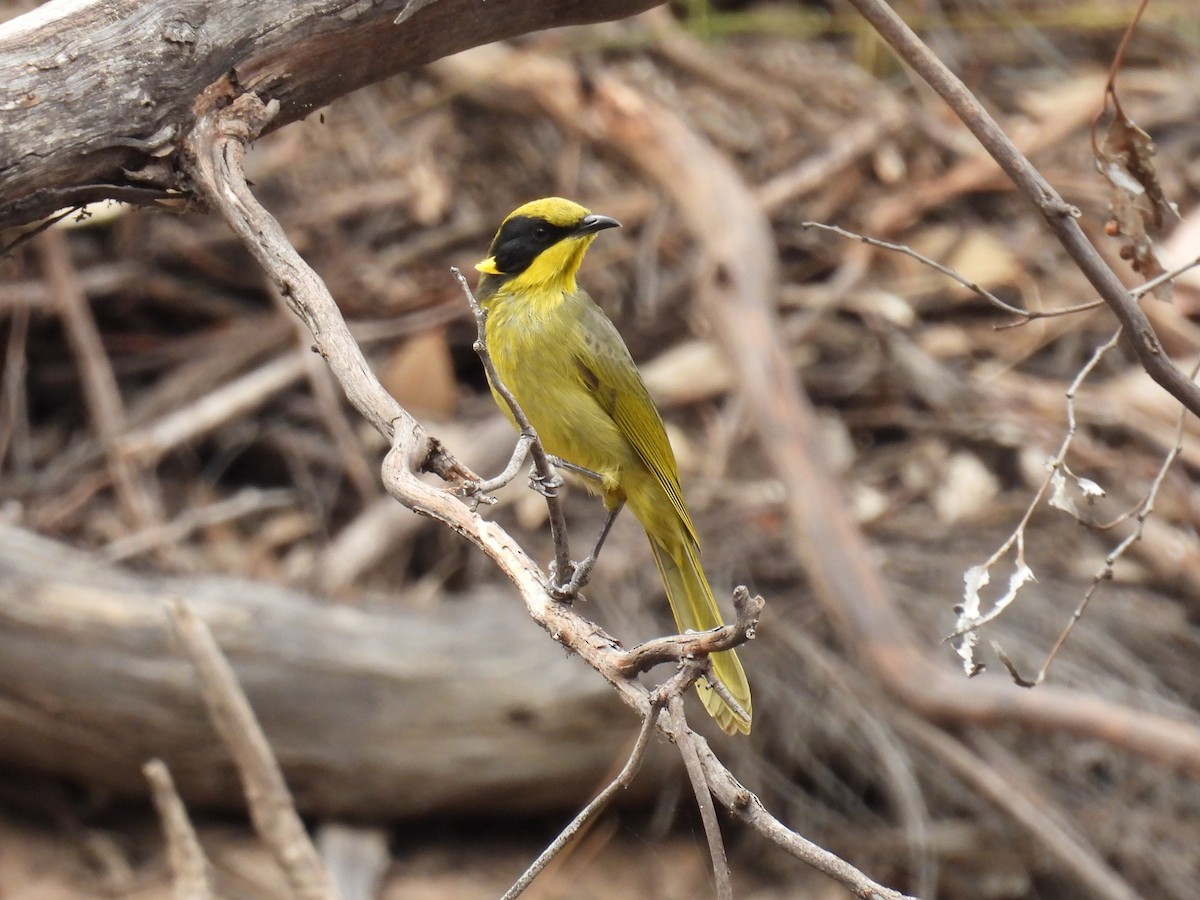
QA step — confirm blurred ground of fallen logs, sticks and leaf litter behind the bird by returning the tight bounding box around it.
[0,0,1200,900]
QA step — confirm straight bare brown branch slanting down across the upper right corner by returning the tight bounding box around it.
[850,0,1200,416]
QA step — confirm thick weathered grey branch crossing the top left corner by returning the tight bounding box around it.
[0,0,656,228]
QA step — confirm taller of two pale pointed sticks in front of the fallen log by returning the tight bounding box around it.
[168,599,337,900]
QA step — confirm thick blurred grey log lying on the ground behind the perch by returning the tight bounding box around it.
[0,524,655,818]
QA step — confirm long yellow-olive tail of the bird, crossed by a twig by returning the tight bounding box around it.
[648,534,751,734]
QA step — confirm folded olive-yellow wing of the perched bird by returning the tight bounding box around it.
[575,300,700,545]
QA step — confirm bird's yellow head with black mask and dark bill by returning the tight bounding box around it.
[475,197,620,295]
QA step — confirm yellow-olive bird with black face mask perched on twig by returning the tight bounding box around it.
[475,197,752,734]
